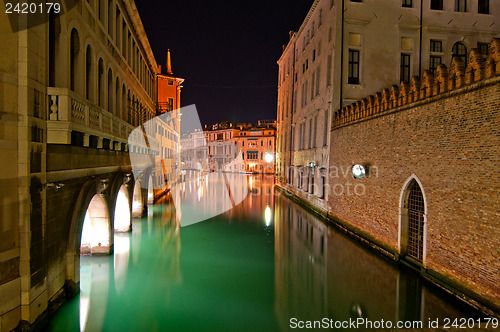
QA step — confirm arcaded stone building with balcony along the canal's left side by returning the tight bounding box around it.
[0,0,158,331]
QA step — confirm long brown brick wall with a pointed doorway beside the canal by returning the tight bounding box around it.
[329,40,500,311]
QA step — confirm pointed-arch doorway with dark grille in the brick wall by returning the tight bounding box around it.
[401,178,426,265]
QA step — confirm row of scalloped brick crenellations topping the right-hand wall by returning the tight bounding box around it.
[333,38,500,128]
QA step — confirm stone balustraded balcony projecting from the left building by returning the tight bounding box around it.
[47,88,134,150]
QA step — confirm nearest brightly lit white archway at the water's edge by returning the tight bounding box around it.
[80,195,110,255]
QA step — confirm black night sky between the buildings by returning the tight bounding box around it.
[136,0,313,124]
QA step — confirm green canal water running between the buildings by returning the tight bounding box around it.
[46,176,478,331]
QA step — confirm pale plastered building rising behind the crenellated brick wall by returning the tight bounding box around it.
[276,0,500,211]
